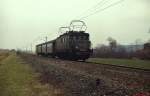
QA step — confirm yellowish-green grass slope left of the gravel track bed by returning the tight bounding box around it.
[0,54,53,96]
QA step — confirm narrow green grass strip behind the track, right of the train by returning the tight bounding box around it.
[87,58,150,69]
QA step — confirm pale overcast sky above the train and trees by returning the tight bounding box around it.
[0,0,150,49]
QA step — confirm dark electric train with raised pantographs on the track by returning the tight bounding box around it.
[36,20,92,60]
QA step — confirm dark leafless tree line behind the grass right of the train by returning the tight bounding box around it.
[93,37,150,59]
